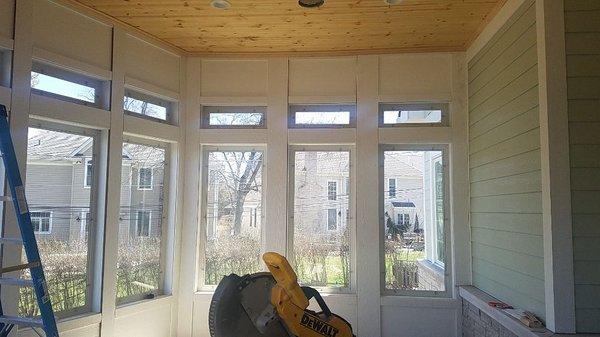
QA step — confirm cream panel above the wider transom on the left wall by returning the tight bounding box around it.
[33,0,112,70]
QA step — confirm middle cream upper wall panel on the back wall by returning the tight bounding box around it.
[289,57,356,98]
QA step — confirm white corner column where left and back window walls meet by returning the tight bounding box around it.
[177,57,202,337]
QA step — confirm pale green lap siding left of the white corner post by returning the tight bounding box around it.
[468,1,545,317]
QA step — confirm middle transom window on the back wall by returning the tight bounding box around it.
[289,105,356,128]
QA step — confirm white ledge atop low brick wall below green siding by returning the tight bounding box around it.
[459,286,559,337]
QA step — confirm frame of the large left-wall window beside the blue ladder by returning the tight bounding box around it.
[28,121,105,318]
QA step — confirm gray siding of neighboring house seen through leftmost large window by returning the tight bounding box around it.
[25,162,73,240]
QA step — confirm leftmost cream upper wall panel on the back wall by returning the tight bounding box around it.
[201,59,267,97]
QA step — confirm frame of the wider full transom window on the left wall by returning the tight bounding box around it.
[31,62,110,110]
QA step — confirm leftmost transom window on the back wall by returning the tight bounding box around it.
[202,106,267,128]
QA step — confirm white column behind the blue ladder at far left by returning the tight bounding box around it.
[2,0,33,322]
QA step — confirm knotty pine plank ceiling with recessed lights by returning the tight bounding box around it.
[76,0,506,55]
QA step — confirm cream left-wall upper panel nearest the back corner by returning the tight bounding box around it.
[125,35,181,93]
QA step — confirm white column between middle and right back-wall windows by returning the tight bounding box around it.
[356,55,382,336]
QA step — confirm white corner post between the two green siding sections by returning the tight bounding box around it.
[536,0,575,333]
